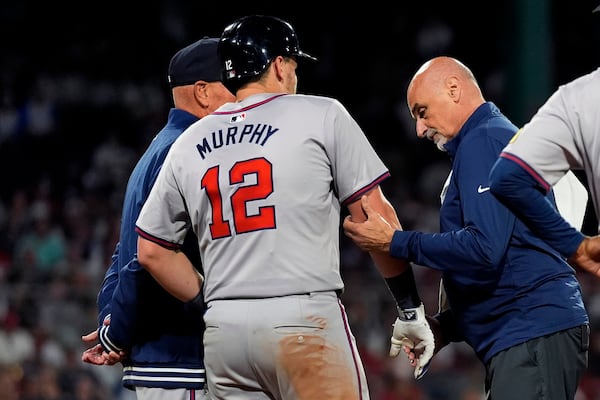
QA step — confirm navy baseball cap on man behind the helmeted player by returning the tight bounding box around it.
[168,37,222,88]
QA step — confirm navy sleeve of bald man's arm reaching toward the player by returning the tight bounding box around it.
[390,135,515,284]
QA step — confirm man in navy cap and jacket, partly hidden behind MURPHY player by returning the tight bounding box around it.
[83,38,234,400]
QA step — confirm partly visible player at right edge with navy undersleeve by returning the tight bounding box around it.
[490,64,600,276]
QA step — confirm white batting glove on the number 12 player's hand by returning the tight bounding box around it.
[390,304,435,379]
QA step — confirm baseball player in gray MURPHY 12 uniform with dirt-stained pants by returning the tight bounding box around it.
[137,15,433,400]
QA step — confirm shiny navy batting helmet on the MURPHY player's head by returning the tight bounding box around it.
[218,15,316,93]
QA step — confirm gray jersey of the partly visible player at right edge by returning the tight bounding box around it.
[504,68,600,227]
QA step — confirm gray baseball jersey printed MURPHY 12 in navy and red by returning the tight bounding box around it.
[137,94,389,302]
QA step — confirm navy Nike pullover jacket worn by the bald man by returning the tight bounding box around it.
[390,102,588,363]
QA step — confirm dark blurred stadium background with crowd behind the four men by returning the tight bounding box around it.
[0,0,600,400]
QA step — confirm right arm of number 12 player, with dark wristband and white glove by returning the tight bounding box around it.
[348,186,435,379]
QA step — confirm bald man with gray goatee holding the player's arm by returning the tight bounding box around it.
[344,57,588,400]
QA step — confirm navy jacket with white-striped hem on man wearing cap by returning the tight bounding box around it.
[98,108,205,389]
